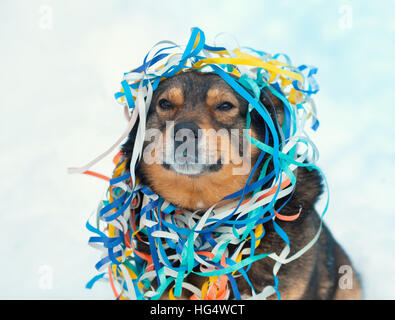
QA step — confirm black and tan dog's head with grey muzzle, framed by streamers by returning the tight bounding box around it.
[123,71,283,210]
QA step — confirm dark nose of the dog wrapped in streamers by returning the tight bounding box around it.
[174,122,200,158]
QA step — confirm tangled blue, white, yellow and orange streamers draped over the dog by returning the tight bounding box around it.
[70,28,329,299]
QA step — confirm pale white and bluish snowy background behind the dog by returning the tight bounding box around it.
[0,0,395,299]
